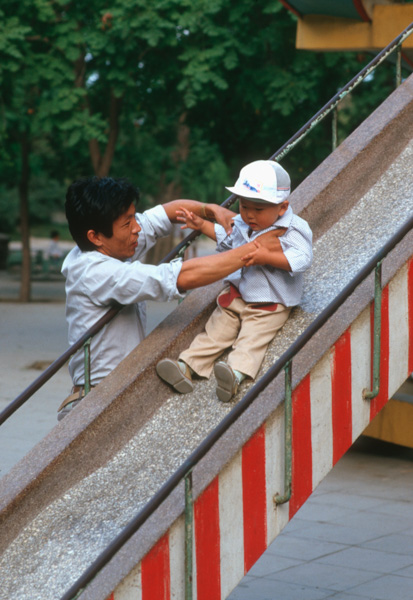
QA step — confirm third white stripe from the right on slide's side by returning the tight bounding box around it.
[310,351,333,489]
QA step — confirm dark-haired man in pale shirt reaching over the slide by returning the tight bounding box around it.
[58,177,276,420]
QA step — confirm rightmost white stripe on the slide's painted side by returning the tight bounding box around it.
[389,264,409,398]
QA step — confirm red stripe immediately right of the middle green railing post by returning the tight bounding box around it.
[290,375,313,519]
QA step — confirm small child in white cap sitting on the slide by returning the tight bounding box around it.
[156,160,312,402]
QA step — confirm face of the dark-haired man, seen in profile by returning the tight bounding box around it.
[88,204,141,260]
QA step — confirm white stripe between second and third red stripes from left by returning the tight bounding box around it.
[218,451,244,598]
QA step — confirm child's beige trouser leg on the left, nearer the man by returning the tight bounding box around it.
[179,301,240,377]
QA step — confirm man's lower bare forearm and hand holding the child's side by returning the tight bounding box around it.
[177,231,279,292]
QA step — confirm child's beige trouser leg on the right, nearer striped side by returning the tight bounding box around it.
[228,304,291,379]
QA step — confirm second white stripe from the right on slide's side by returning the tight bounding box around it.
[350,306,371,442]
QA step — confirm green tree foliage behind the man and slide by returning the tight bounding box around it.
[0,0,400,298]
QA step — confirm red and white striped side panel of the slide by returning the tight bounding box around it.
[108,259,413,600]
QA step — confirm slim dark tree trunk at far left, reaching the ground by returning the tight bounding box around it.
[19,131,31,302]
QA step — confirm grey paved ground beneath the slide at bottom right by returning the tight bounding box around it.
[229,438,413,600]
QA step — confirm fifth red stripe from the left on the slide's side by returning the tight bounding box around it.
[331,329,353,465]
